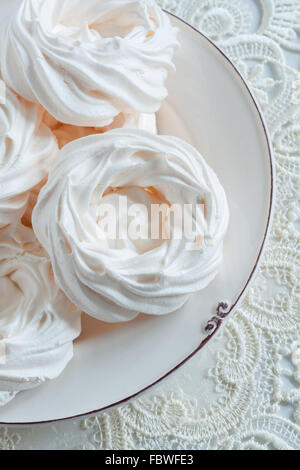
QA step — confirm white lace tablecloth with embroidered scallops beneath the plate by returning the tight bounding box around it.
[0,0,300,450]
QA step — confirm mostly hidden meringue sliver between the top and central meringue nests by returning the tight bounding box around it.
[43,112,157,149]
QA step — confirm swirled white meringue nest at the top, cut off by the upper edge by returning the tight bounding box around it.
[0,0,178,127]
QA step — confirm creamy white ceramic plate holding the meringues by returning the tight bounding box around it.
[0,9,273,424]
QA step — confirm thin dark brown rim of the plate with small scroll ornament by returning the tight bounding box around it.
[0,9,275,427]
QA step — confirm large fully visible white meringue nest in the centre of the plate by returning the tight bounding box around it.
[33,129,229,322]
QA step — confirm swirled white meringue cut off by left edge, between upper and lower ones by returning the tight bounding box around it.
[0,88,58,227]
